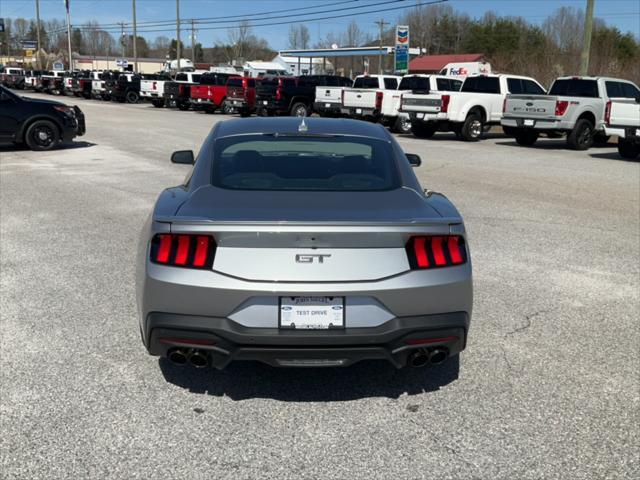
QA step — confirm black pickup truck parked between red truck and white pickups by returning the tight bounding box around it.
[256,75,350,117]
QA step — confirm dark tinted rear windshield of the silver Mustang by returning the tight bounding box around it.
[212,135,399,192]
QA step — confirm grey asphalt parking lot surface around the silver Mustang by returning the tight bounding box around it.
[0,94,640,479]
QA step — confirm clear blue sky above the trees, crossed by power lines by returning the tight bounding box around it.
[0,0,640,49]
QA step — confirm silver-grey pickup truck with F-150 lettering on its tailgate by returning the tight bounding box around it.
[501,77,640,150]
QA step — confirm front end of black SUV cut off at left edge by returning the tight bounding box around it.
[0,86,85,150]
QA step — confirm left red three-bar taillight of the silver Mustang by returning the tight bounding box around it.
[151,233,216,269]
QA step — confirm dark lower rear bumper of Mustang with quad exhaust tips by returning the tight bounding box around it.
[144,312,469,369]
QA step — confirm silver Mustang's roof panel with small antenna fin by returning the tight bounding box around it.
[216,117,389,141]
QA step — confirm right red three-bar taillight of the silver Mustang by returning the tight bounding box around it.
[406,235,467,270]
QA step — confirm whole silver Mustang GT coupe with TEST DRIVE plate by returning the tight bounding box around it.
[137,117,472,368]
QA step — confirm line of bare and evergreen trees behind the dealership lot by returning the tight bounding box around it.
[0,5,640,85]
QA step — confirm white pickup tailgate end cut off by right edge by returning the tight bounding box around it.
[604,97,640,160]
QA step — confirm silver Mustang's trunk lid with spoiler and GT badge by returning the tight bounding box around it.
[166,187,451,282]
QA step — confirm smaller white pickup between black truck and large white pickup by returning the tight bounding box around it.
[341,75,411,132]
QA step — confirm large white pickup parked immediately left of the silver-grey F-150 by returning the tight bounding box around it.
[401,75,545,142]
